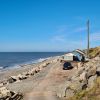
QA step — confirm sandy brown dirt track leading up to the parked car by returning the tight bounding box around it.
[25,62,75,100]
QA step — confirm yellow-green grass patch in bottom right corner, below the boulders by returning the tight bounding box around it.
[69,77,100,100]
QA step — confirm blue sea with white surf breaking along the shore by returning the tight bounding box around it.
[0,52,64,70]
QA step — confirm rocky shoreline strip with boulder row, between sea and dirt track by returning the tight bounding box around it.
[0,57,58,100]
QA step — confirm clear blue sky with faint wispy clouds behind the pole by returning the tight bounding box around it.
[0,0,100,52]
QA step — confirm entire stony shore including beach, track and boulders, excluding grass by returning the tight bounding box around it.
[0,51,100,100]
